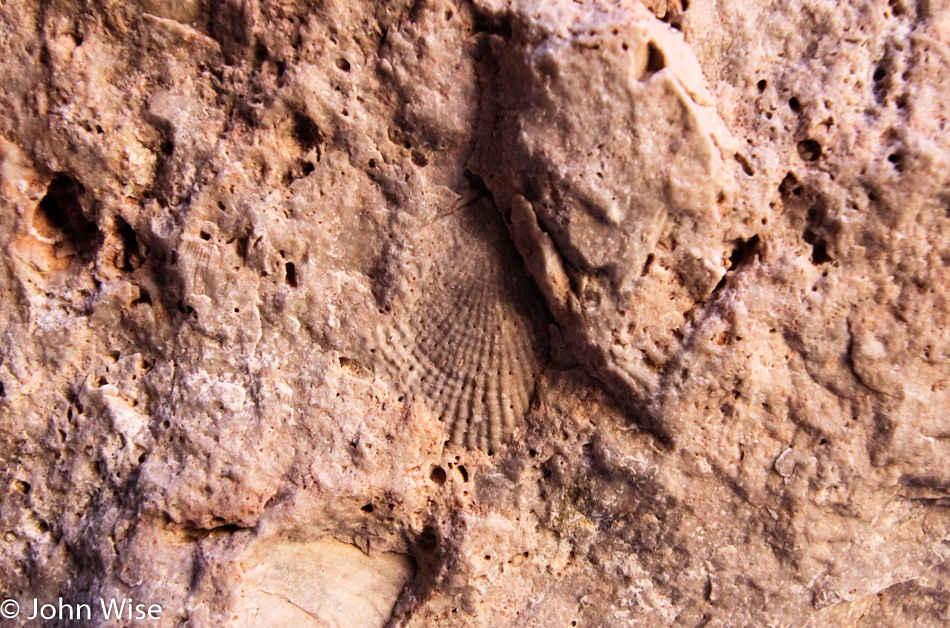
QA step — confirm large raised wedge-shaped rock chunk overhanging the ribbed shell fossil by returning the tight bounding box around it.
[473,4,754,432]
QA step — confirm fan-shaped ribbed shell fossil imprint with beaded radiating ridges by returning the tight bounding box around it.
[375,197,549,451]
